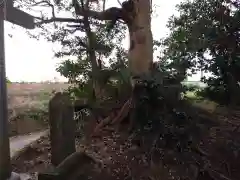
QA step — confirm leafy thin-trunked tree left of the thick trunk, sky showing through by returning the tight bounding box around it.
[17,0,126,100]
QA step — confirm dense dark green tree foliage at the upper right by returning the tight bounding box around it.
[163,0,240,104]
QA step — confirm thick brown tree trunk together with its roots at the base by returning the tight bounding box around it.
[122,0,153,131]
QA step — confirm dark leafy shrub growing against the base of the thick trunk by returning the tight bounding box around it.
[134,62,184,129]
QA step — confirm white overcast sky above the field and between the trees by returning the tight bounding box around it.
[5,0,200,81]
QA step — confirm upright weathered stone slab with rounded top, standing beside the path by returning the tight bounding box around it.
[49,92,76,166]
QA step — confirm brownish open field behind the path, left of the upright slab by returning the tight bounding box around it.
[7,83,69,136]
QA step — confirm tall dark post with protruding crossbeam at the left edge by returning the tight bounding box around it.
[0,0,34,180]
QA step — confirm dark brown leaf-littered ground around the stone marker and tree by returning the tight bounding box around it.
[12,103,240,180]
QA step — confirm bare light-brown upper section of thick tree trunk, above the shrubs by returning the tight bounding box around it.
[127,0,153,79]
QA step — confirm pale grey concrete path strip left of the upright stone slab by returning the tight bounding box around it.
[9,130,48,158]
